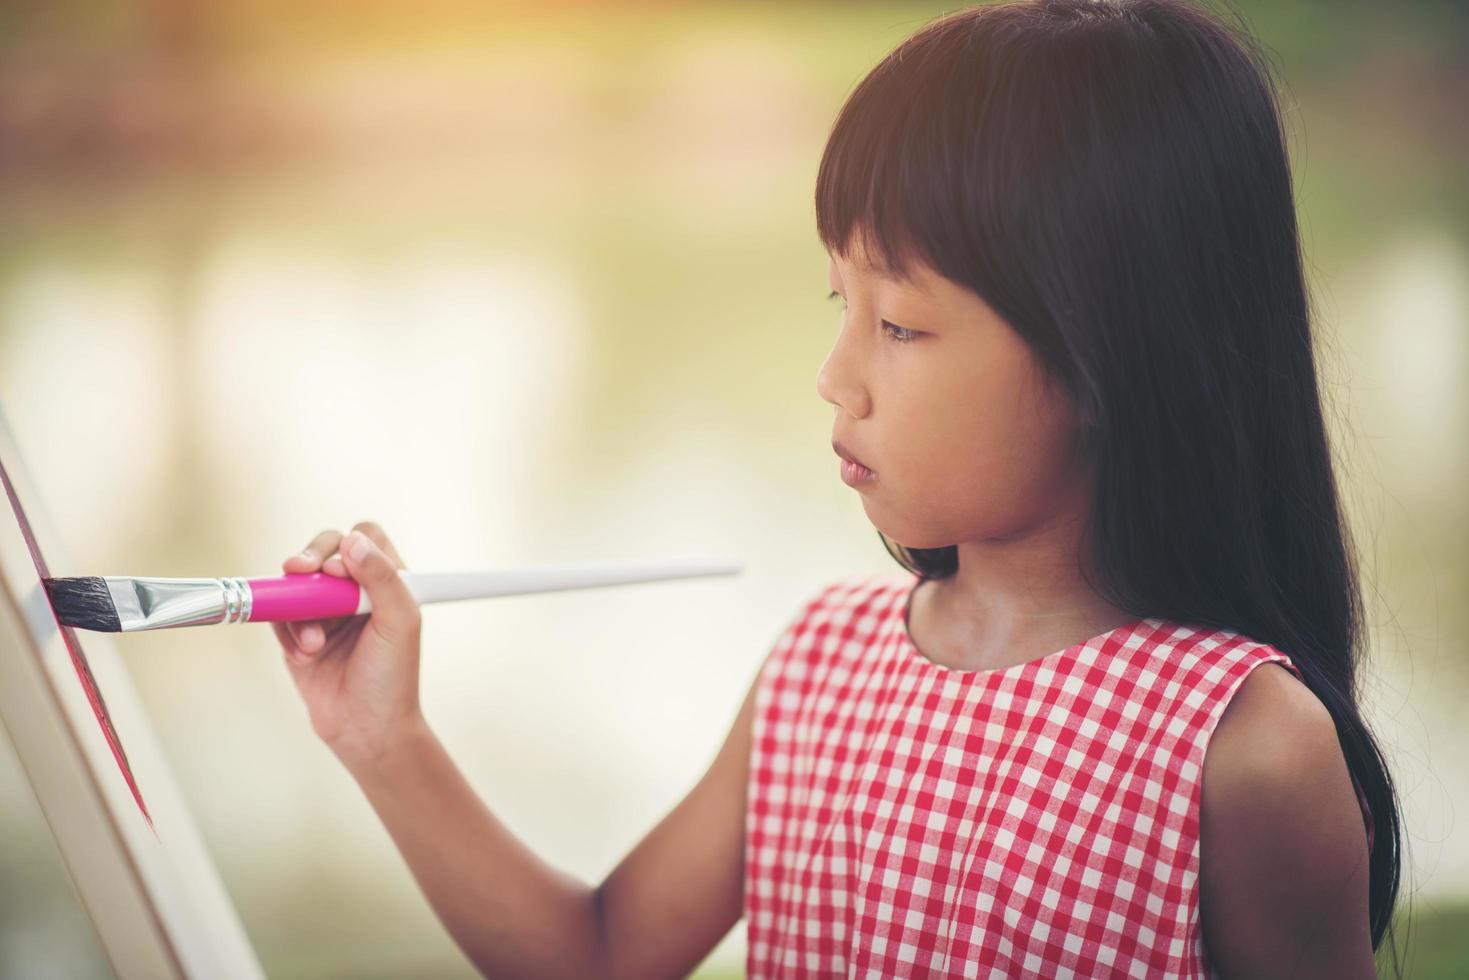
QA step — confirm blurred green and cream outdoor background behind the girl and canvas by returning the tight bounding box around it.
[0,0,1469,977]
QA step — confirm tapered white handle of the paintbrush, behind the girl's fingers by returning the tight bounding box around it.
[357,560,745,614]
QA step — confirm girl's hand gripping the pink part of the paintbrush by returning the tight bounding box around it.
[272,522,423,768]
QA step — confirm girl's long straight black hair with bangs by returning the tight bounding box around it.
[815,0,1401,971]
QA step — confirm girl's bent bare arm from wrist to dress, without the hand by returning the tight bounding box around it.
[350,669,754,979]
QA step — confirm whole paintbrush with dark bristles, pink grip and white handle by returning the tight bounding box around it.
[41,560,743,633]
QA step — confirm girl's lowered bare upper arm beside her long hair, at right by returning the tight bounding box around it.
[1199,664,1376,980]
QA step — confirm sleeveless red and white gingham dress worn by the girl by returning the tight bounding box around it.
[745,573,1363,980]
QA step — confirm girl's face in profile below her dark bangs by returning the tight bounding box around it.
[817,237,1087,548]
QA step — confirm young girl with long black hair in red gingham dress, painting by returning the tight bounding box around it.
[278,0,1398,979]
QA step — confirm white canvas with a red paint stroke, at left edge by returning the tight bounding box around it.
[0,402,264,980]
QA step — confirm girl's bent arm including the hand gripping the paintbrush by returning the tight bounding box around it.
[273,522,755,979]
